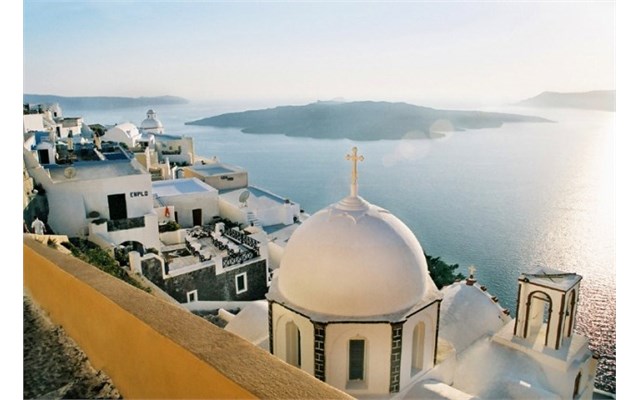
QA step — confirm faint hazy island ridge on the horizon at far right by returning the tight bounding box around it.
[517,90,616,111]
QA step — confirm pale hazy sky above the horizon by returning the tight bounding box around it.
[23,0,615,104]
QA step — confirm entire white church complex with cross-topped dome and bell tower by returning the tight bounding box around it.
[229,148,597,399]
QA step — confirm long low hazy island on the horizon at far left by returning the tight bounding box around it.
[22,94,189,110]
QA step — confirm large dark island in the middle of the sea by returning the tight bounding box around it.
[186,101,552,141]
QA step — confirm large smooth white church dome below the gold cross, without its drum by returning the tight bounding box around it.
[274,193,439,317]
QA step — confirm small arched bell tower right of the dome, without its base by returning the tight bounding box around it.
[513,267,582,350]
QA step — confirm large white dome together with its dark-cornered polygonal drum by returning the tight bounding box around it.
[267,148,442,395]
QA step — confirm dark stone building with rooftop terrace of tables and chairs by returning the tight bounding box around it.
[135,223,269,309]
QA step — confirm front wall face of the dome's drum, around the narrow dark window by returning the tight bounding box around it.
[325,323,391,397]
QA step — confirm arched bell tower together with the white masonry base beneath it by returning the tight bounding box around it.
[492,267,598,399]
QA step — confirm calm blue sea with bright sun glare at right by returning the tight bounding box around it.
[63,101,616,393]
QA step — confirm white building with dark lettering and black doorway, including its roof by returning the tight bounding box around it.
[24,149,161,248]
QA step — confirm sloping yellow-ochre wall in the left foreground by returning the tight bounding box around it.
[23,238,347,399]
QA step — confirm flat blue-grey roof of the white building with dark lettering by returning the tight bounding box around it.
[44,160,147,182]
